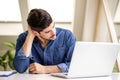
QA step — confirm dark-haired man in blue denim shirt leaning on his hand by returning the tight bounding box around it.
[13,9,75,74]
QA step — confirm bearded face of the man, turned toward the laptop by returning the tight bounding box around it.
[40,22,56,40]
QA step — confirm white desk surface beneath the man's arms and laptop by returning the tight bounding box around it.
[0,73,120,80]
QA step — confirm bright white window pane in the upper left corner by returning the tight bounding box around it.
[0,0,21,21]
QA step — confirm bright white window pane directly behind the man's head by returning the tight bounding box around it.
[30,0,74,22]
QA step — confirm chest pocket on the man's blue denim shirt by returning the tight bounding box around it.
[53,47,66,64]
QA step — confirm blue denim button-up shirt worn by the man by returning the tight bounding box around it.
[13,28,76,73]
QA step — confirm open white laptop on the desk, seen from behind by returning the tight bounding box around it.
[51,41,120,78]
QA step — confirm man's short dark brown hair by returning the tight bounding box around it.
[27,9,53,32]
